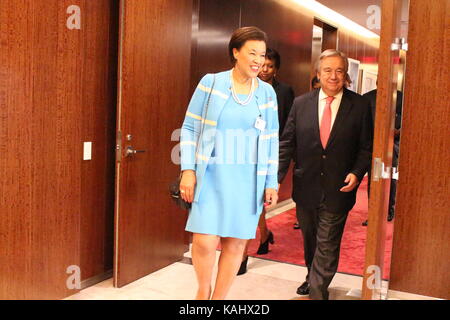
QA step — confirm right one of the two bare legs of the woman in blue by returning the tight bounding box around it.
[212,238,248,300]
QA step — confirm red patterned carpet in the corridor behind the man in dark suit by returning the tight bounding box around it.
[248,178,393,279]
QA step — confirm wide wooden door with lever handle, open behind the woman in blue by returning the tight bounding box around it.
[114,0,192,287]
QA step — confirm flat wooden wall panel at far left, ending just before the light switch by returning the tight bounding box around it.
[0,0,83,299]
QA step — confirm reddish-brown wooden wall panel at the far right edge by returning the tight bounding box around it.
[389,0,450,299]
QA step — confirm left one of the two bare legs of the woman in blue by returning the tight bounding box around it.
[192,233,220,300]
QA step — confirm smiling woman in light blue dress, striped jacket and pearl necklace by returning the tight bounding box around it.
[180,27,278,299]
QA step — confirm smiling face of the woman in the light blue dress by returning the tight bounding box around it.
[233,40,266,78]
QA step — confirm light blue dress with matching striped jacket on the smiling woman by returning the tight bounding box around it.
[181,71,278,239]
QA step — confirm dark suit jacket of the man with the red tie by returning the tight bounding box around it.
[278,89,372,213]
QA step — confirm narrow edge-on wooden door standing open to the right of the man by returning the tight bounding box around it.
[362,0,401,300]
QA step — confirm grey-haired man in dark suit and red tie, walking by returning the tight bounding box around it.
[278,50,372,299]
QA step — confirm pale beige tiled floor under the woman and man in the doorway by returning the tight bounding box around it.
[68,251,370,300]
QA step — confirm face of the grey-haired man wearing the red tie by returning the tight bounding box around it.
[317,56,346,96]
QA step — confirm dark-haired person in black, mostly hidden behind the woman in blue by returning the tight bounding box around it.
[238,48,295,275]
